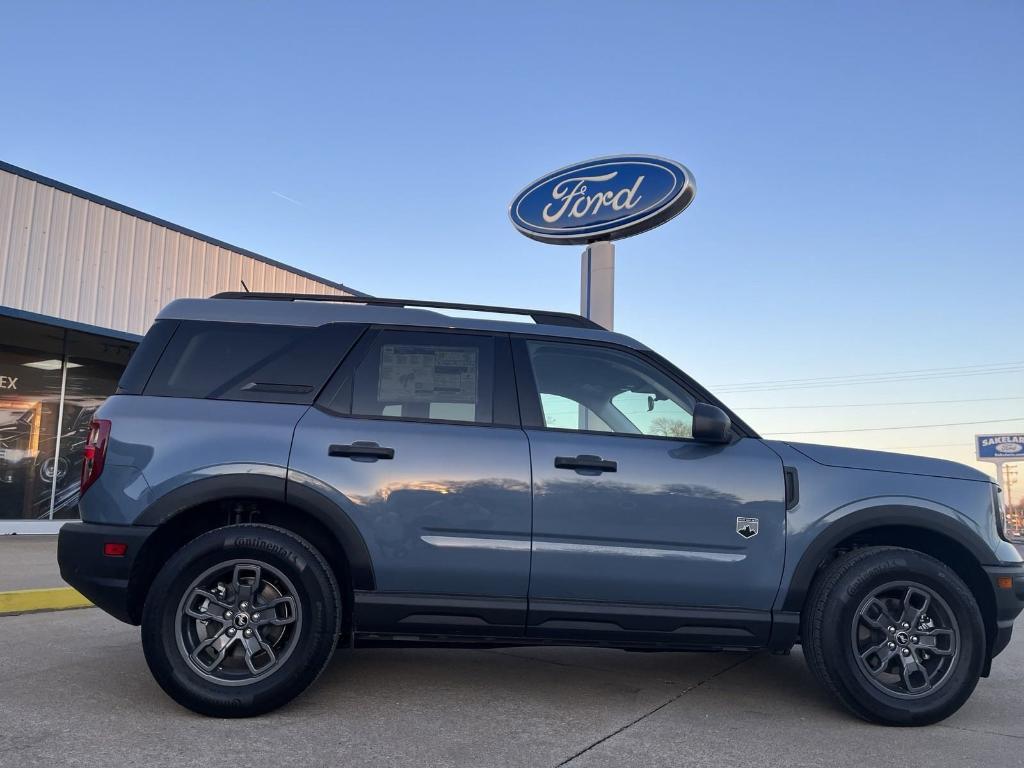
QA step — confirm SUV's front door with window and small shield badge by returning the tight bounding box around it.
[514,338,785,646]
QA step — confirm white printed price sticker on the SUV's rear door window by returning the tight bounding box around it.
[377,344,480,402]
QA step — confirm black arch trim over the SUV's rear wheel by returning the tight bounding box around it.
[134,468,376,590]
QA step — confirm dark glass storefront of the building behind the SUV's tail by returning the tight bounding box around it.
[0,316,136,520]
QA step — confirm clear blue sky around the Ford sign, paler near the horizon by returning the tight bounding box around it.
[0,0,1024,481]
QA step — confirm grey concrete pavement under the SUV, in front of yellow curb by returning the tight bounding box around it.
[0,608,1024,768]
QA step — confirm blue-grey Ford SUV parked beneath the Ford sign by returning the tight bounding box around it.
[58,293,1024,725]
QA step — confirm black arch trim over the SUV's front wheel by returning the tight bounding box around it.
[779,504,995,612]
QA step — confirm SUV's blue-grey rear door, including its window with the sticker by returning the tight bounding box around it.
[289,328,530,635]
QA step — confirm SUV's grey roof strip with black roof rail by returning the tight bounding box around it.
[157,296,647,349]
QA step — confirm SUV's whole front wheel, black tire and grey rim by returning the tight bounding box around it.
[801,547,985,726]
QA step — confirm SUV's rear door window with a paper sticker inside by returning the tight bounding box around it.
[351,331,495,424]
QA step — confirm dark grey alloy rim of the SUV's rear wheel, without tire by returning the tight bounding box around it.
[176,559,302,685]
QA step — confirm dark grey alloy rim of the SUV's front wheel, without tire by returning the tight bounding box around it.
[852,581,961,698]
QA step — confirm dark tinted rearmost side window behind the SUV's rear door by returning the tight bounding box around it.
[145,322,362,404]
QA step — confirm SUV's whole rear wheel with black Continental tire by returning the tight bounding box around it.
[142,524,342,718]
